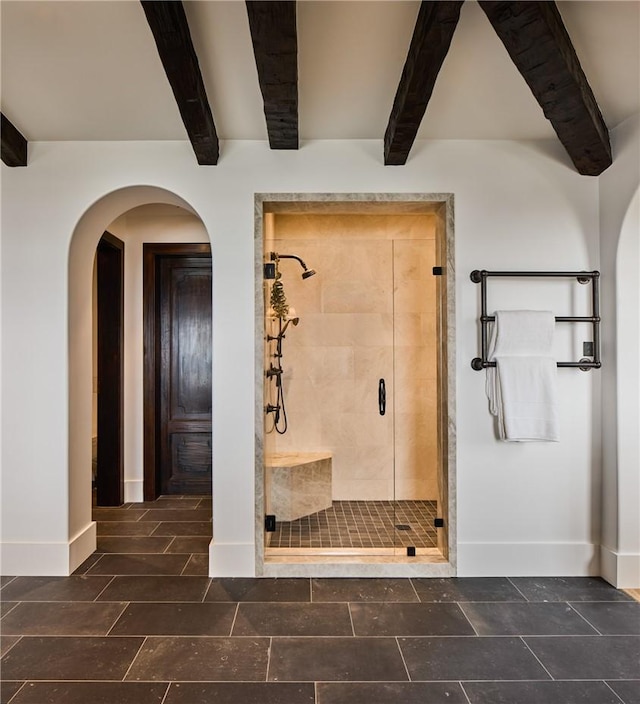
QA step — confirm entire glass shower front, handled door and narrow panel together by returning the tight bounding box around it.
[264,228,438,558]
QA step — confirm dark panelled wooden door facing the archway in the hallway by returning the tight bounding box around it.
[158,256,212,494]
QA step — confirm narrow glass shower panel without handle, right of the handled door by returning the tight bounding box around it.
[393,239,441,557]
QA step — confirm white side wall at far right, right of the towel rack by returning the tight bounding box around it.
[600,116,640,587]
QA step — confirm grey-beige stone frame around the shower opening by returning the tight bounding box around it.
[255,193,456,577]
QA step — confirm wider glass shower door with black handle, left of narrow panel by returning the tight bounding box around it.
[265,237,395,556]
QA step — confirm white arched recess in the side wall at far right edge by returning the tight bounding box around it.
[616,188,640,588]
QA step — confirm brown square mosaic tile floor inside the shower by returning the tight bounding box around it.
[269,501,437,548]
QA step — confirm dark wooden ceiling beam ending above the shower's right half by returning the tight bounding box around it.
[384,0,464,166]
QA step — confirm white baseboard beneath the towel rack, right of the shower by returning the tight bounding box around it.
[458,543,600,577]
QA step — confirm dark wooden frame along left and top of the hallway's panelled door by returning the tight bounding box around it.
[142,243,211,501]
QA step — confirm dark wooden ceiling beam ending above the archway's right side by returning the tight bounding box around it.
[140,0,220,166]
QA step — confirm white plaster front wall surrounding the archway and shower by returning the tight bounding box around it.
[1,136,600,575]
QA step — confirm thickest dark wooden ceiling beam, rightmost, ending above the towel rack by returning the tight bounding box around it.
[479,0,612,176]
